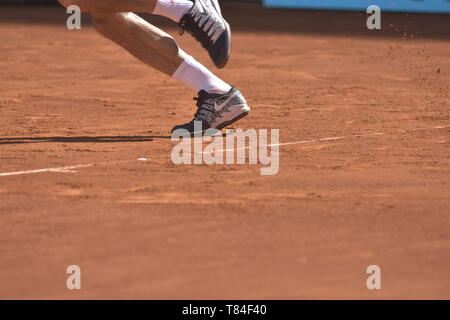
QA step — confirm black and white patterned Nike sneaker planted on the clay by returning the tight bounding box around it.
[172,88,250,134]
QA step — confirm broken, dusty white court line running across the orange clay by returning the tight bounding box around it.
[0,125,450,177]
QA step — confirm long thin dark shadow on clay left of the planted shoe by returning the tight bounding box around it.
[0,136,171,145]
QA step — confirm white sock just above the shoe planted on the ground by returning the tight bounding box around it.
[172,56,231,94]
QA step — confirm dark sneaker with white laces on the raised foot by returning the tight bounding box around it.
[179,0,231,68]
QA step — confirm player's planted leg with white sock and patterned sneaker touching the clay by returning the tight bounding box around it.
[57,0,250,132]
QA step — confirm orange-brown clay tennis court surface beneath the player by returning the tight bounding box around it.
[0,6,450,299]
